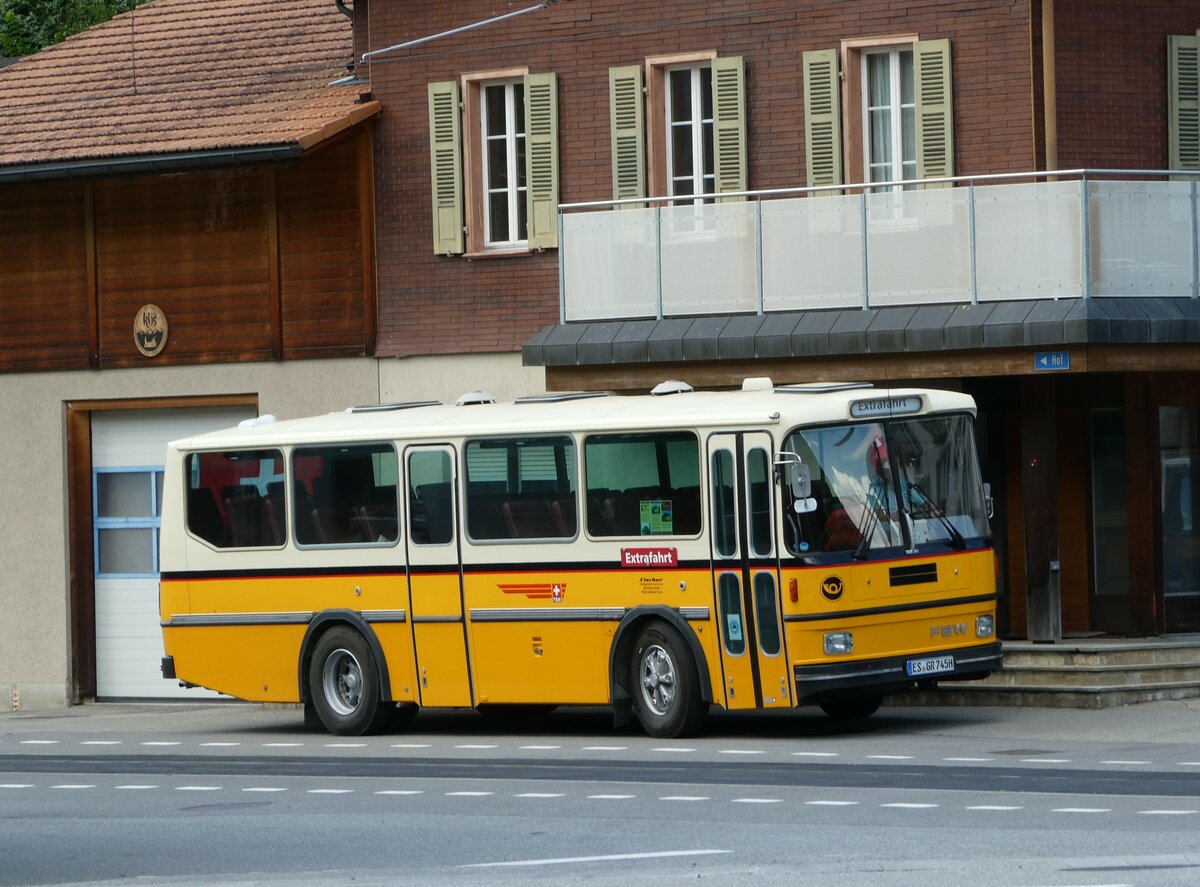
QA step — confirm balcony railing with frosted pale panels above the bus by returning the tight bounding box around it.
[558,169,1200,323]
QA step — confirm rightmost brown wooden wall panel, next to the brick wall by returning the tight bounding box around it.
[277,140,370,358]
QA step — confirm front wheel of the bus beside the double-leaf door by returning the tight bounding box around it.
[630,622,707,739]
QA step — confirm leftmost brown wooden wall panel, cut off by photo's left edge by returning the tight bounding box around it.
[0,182,91,372]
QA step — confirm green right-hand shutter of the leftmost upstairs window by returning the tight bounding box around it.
[524,73,558,250]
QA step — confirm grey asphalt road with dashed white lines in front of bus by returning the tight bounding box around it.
[0,700,1200,887]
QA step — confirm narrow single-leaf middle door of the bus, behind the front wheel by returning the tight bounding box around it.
[404,447,473,706]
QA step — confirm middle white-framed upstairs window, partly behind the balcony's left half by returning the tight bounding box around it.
[664,65,716,204]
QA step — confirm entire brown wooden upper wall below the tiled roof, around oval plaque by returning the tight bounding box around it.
[0,127,374,372]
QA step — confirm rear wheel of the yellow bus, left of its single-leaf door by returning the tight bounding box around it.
[308,625,395,736]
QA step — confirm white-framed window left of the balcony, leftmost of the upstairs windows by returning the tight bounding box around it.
[480,80,529,250]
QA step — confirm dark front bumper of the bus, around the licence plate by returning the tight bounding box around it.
[796,641,1002,705]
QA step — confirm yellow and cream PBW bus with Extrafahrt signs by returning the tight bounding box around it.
[160,379,1001,737]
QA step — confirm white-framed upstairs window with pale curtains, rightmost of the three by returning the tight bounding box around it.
[862,47,917,190]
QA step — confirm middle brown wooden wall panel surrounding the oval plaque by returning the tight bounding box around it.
[96,169,271,367]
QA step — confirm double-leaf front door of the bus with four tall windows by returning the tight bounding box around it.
[708,432,792,708]
